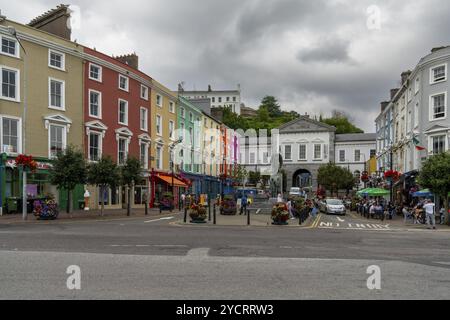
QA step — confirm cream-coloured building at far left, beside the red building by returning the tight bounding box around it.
[0,17,84,209]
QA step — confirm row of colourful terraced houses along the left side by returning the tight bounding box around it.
[0,5,239,208]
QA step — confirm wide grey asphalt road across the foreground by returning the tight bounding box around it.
[0,212,450,300]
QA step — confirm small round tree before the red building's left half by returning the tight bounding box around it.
[87,156,120,216]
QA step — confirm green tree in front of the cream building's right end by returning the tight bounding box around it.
[49,145,86,213]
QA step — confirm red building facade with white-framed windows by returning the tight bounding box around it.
[84,48,152,208]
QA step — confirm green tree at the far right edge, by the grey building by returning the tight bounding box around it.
[418,152,450,224]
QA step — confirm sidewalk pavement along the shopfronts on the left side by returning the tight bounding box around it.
[0,208,180,224]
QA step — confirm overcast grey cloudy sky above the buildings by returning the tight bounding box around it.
[0,0,450,132]
